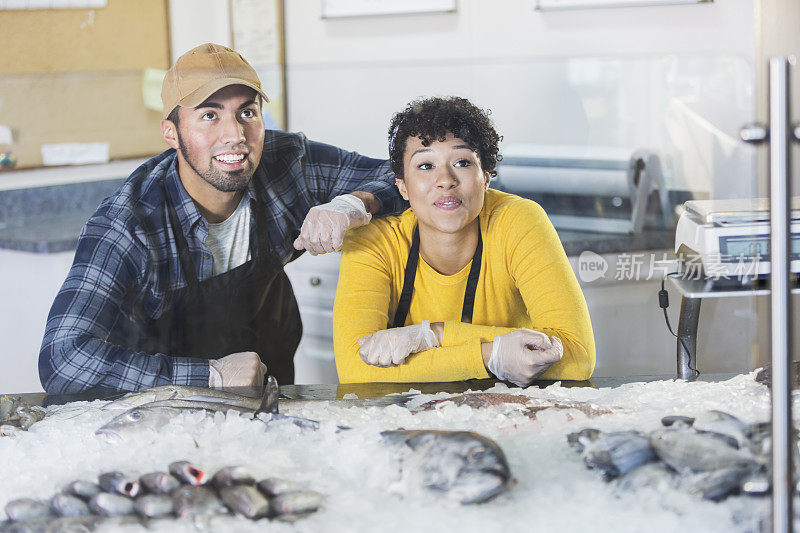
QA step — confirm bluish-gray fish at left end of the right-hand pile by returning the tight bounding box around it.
[582,431,656,480]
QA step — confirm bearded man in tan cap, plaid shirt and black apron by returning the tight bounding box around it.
[39,44,402,394]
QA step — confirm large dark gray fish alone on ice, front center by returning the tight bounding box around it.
[381,430,511,504]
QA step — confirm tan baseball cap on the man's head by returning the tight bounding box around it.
[161,43,269,118]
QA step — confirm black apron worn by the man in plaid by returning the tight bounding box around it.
[115,183,303,385]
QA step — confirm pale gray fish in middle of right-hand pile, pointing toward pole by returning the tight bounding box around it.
[649,428,758,474]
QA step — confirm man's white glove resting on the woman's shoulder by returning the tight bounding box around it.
[294,194,372,255]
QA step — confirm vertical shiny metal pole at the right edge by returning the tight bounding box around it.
[769,57,794,533]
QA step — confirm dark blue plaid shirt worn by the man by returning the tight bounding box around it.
[39,131,404,394]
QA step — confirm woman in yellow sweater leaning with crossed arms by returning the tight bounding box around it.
[333,97,595,386]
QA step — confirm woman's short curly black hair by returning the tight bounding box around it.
[389,96,503,179]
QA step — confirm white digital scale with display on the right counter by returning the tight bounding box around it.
[675,197,800,281]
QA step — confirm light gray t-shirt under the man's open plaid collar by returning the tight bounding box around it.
[206,195,250,276]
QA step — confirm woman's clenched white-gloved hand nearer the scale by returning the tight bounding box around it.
[487,329,564,387]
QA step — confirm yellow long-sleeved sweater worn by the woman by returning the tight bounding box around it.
[333,189,595,383]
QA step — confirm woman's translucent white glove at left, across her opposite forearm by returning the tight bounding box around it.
[358,320,439,366]
